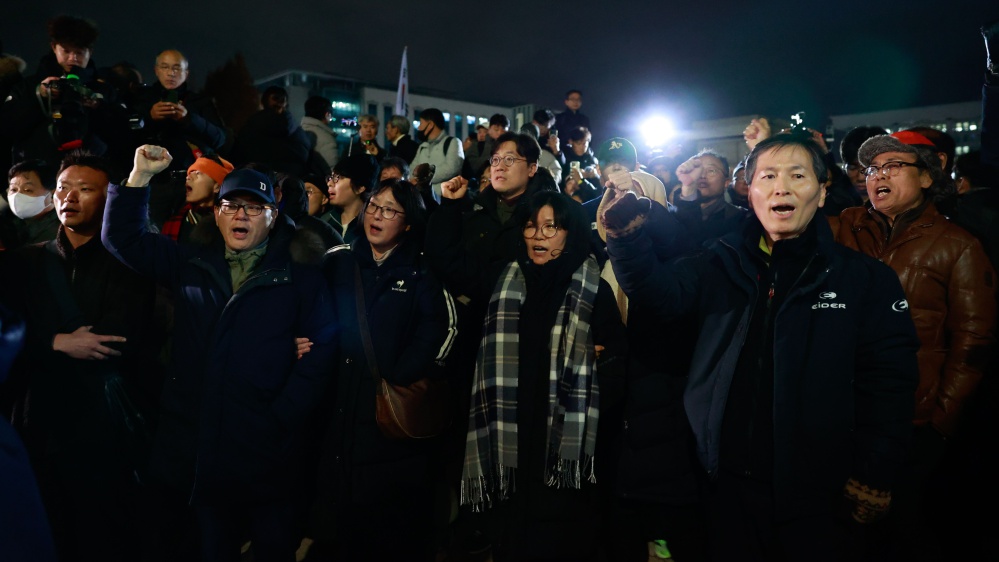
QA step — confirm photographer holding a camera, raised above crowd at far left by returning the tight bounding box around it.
[0,16,129,172]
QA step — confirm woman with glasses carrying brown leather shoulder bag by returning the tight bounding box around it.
[309,179,456,561]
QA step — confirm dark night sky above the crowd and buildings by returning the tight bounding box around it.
[0,0,999,142]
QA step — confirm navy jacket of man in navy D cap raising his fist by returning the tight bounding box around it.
[102,185,336,503]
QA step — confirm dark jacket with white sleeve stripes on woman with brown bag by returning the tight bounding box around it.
[319,236,458,506]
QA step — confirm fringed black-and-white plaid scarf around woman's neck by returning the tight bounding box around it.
[461,257,600,511]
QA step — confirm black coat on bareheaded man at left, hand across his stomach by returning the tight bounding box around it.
[2,224,162,561]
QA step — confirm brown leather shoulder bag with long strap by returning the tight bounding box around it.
[354,262,452,439]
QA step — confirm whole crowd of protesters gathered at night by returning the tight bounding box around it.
[0,10,999,562]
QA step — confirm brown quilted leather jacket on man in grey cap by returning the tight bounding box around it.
[836,203,996,435]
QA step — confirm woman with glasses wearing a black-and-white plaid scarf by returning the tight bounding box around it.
[460,192,626,561]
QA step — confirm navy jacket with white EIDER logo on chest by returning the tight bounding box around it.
[607,205,919,520]
